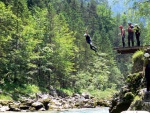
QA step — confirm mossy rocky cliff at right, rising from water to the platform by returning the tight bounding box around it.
[110,49,150,113]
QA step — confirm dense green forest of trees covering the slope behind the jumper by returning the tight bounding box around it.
[0,0,150,98]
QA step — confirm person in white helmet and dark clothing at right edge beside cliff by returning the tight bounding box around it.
[143,52,150,92]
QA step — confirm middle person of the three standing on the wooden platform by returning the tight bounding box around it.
[127,23,134,47]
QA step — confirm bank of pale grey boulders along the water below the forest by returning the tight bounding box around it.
[0,93,109,112]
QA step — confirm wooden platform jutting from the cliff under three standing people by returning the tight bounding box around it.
[114,45,150,54]
